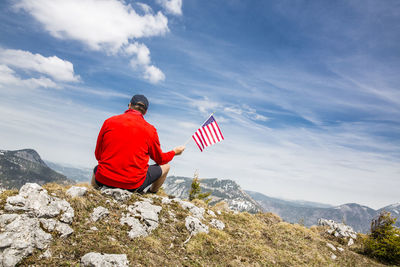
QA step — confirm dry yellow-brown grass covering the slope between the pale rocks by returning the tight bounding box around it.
[0,184,388,266]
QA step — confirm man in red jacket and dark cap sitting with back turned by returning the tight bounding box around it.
[92,95,185,193]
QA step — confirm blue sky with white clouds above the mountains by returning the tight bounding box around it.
[0,0,400,209]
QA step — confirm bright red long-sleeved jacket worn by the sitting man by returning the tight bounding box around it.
[95,109,175,189]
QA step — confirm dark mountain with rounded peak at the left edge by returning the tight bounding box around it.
[0,149,73,191]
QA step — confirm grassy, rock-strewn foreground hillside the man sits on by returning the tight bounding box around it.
[0,184,388,266]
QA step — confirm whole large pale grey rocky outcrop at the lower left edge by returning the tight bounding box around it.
[0,183,74,267]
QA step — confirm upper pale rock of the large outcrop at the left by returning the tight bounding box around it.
[4,183,74,223]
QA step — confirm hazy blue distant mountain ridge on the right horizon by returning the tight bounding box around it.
[247,191,394,233]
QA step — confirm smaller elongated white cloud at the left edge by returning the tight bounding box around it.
[0,49,79,82]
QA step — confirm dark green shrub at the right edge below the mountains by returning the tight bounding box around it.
[364,211,400,264]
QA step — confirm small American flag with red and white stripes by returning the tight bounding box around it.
[192,115,224,151]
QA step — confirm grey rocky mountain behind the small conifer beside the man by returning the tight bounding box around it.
[163,176,262,213]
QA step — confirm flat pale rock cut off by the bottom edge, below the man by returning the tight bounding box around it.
[81,252,129,267]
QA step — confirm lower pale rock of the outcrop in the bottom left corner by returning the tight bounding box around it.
[0,214,52,267]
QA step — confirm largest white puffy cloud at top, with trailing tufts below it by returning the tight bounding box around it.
[15,0,169,83]
